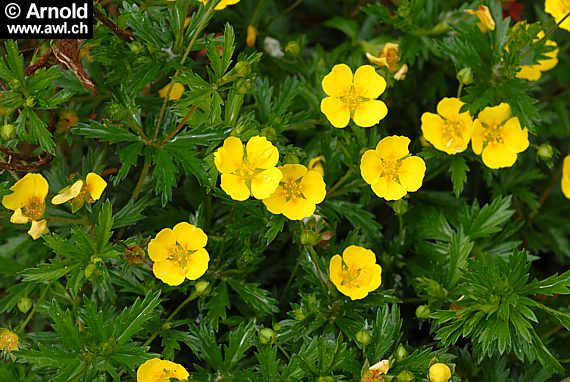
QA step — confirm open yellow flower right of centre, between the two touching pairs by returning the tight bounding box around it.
[360,135,426,200]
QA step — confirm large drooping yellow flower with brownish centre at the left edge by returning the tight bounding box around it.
[2,174,49,224]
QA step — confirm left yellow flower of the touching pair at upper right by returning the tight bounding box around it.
[422,98,473,155]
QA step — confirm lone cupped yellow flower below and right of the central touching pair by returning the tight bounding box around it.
[329,245,382,300]
